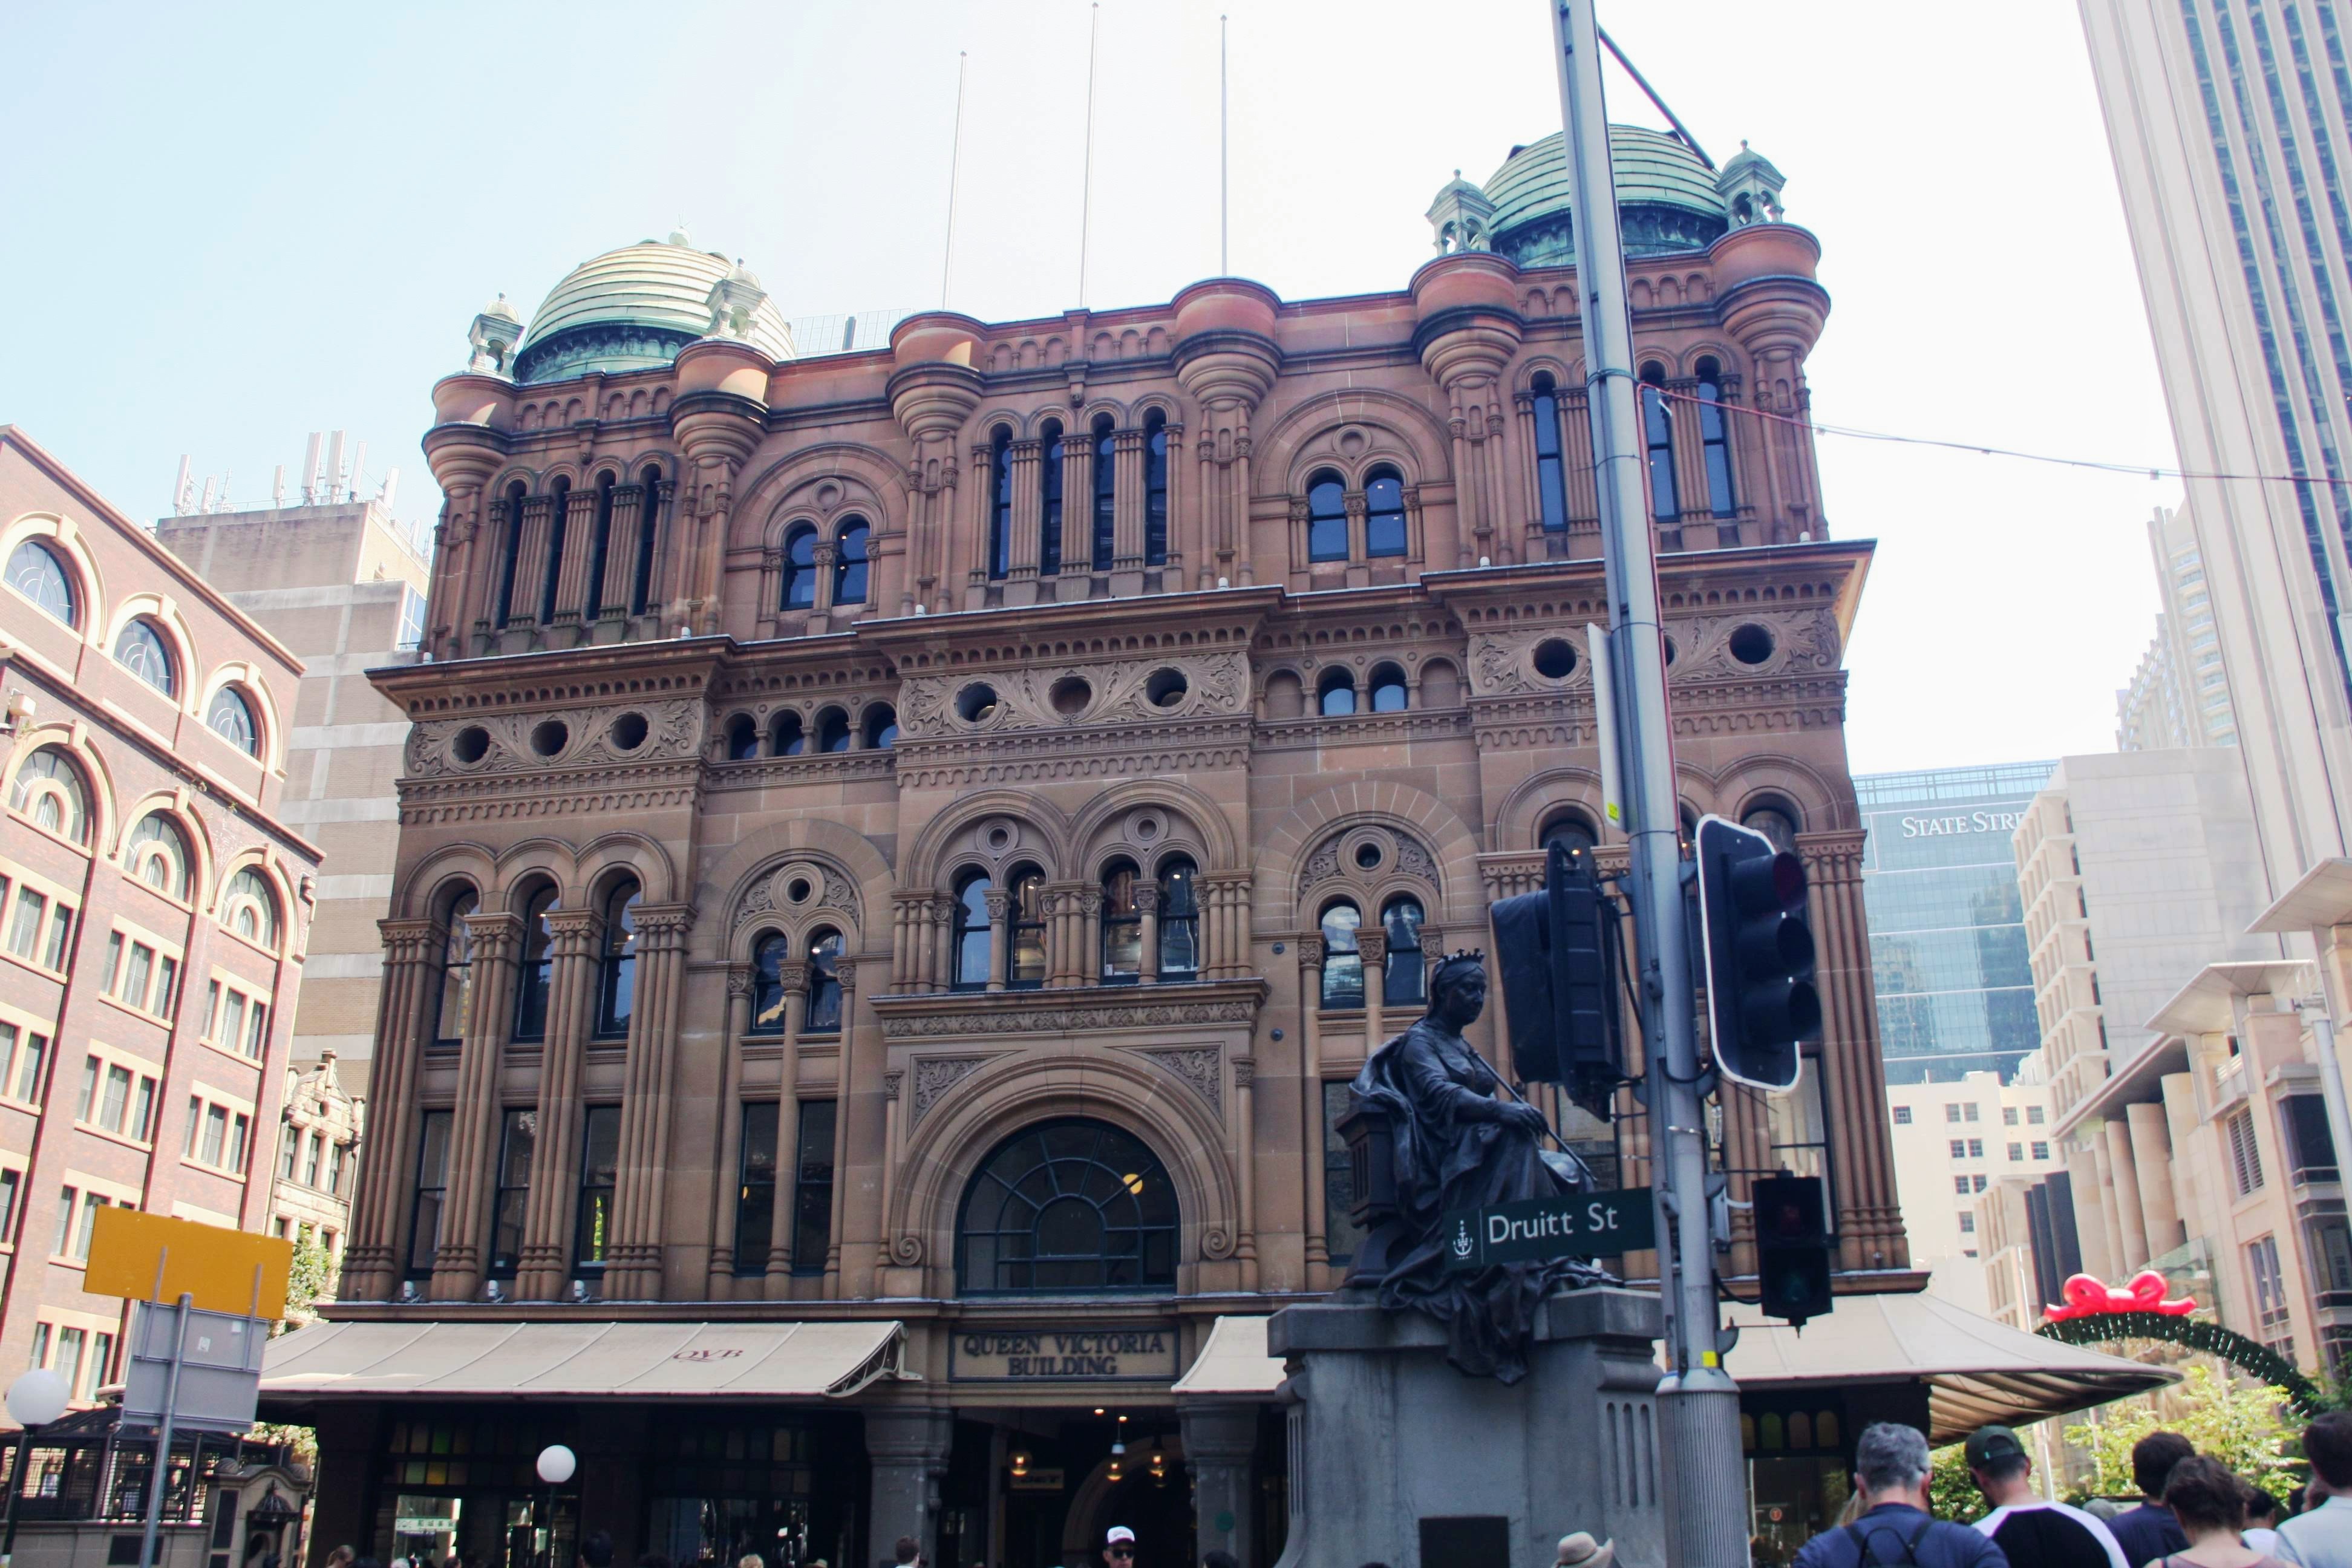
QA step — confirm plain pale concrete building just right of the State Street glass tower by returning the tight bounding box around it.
[2016,748,2281,1117]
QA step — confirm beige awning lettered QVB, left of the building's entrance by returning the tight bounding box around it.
[261,1321,908,1401]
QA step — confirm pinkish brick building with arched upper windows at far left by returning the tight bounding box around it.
[0,425,320,1399]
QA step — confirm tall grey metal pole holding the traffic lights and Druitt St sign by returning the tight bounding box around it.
[1545,0,1748,1568]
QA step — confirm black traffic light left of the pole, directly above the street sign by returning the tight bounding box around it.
[1494,844,1625,1119]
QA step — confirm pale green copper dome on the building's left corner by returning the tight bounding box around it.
[515,233,795,383]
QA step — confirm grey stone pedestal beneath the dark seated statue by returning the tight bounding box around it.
[1268,1289,1665,1568]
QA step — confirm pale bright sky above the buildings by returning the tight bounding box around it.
[0,0,2178,771]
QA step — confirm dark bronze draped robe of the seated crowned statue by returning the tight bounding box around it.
[1354,1018,1609,1382]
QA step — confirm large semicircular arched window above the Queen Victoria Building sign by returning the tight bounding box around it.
[955,1119,1176,1295]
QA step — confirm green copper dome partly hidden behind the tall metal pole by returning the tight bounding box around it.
[1484,125,1731,266]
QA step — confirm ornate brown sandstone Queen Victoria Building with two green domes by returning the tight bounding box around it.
[268,127,1919,1568]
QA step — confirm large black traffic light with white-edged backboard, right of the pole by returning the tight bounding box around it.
[1698,815,1820,1091]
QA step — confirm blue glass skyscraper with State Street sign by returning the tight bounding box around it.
[1854,762,2053,1083]
